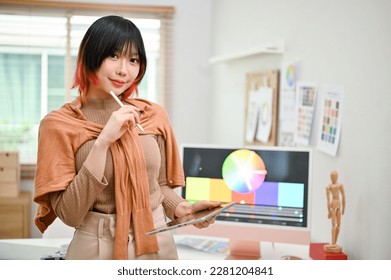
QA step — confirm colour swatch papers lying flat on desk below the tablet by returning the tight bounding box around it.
[176,237,229,254]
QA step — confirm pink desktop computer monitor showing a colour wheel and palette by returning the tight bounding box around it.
[177,144,312,259]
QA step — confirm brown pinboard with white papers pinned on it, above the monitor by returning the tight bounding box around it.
[244,70,279,146]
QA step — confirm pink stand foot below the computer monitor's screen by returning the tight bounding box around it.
[226,239,261,260]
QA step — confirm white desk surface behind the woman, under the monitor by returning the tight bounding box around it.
[0,235,311,260]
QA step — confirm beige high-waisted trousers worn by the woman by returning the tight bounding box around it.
[66,205,178,260]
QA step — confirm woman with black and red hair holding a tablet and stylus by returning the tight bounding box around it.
[34,16,220,259]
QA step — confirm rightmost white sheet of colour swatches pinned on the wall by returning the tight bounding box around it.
[317,85,344,156]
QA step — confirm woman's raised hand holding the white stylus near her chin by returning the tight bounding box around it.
[98,105,140,146]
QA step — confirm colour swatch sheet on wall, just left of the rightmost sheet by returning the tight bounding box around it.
[294,81,318,146]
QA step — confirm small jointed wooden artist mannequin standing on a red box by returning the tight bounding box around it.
[324,171,346,253]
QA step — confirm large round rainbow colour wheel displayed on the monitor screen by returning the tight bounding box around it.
[222,149,267,193]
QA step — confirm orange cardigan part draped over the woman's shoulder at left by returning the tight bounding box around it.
[34,101,101,232]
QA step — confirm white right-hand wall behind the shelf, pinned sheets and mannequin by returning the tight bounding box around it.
[210,0,391,259]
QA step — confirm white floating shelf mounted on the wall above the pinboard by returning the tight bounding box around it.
[209,40,284,64]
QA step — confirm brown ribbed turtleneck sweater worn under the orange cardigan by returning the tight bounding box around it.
[50,99,184,230]
